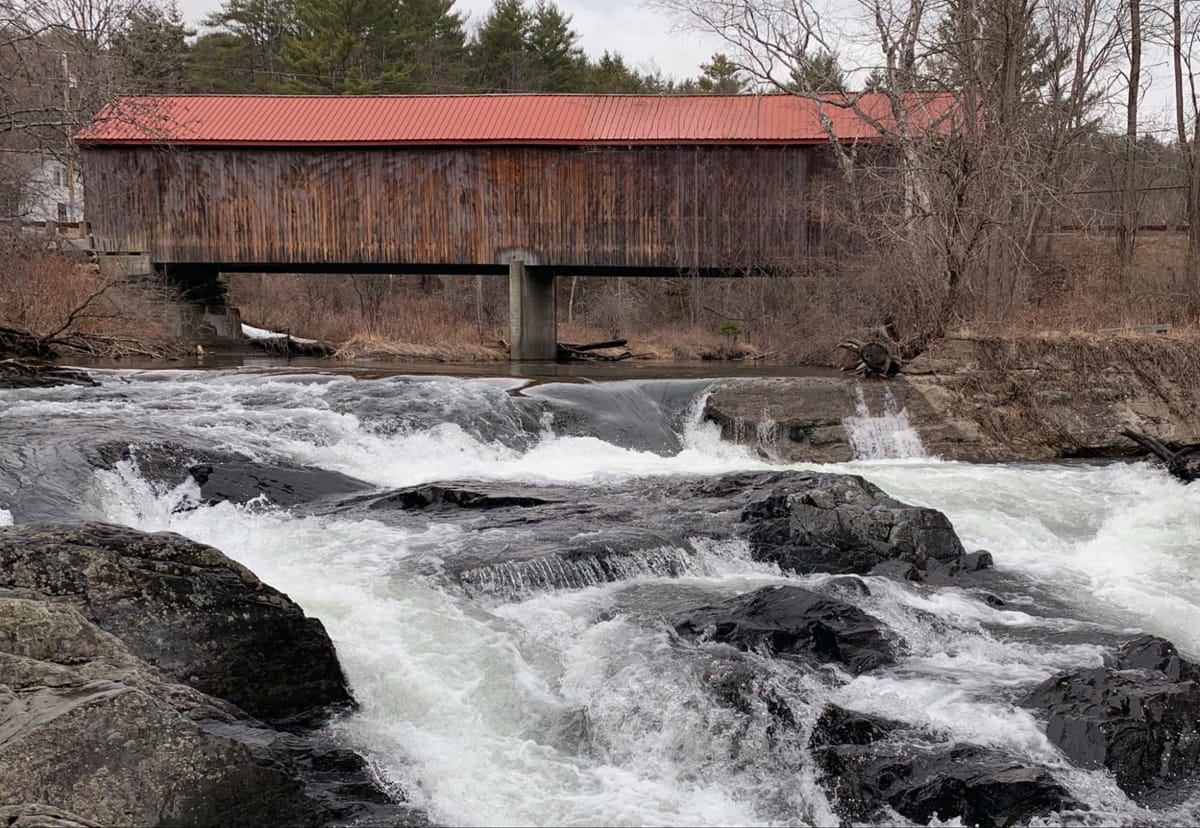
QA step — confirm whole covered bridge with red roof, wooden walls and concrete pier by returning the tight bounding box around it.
[76,95,936,359]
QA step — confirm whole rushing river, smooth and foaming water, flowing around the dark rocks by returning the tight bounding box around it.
[0,371,1200,826]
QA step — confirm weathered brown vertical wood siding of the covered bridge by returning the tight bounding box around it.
[83,146,811,269]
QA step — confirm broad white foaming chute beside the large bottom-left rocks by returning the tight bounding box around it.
[88,474,811,824]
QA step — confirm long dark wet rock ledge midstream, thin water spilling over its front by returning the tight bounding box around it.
[328,472,962,598]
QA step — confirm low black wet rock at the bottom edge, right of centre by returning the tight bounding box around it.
[811,706,1080,828]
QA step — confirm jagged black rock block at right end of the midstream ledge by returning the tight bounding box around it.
[742,474,964,575]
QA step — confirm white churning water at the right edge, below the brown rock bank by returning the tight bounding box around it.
[865,463,1200,658]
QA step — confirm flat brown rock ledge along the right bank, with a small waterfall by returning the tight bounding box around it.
[704,336,1200,463]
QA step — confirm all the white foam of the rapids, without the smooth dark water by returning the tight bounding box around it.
[25,369,1200,824]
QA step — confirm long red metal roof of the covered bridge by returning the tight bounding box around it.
[76,94,949,146]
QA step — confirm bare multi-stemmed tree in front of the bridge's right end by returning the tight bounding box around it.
[652,0,1116,336]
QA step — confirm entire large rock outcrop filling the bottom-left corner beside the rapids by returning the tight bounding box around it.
[0,524,424,826]
